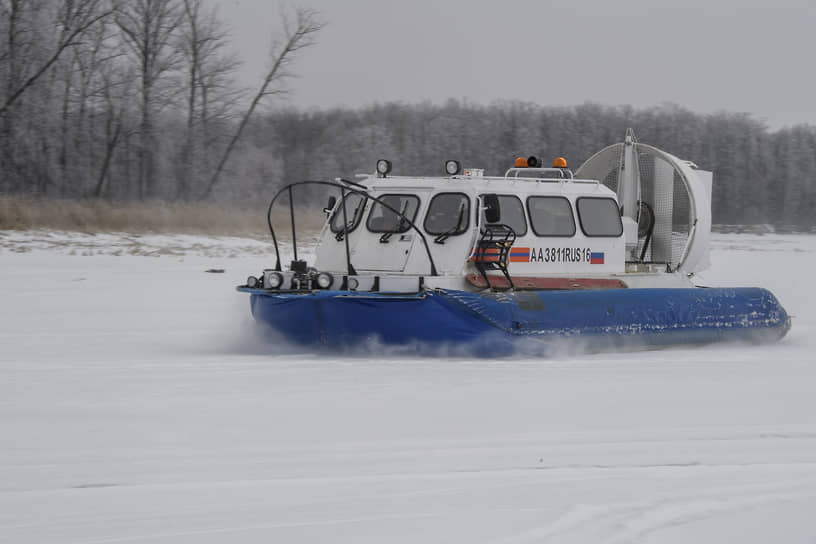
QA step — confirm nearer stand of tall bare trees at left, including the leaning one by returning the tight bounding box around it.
[0,0,323,201]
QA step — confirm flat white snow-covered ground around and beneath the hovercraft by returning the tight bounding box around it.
[0,232,816,544]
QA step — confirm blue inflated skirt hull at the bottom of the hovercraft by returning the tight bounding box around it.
[240,288,790,356]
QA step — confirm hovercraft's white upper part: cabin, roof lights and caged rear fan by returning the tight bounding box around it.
[264,131,711,292]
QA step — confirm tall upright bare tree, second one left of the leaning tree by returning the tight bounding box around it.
[116,0,182,198]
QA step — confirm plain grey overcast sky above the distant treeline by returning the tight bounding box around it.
[214,0,816,128]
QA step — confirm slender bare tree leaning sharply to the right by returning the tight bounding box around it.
[200,8,325,200]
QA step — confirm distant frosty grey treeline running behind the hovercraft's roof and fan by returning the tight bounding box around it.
[262,100,816,227]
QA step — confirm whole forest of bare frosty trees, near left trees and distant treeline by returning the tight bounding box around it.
[0,0,816,228]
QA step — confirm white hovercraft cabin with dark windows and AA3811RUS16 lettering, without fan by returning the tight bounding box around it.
[315,168,626,277]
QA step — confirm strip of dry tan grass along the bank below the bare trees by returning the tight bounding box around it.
[0,197,325,237]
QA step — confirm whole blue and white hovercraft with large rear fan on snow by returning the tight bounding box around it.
[238,129,790,356]
